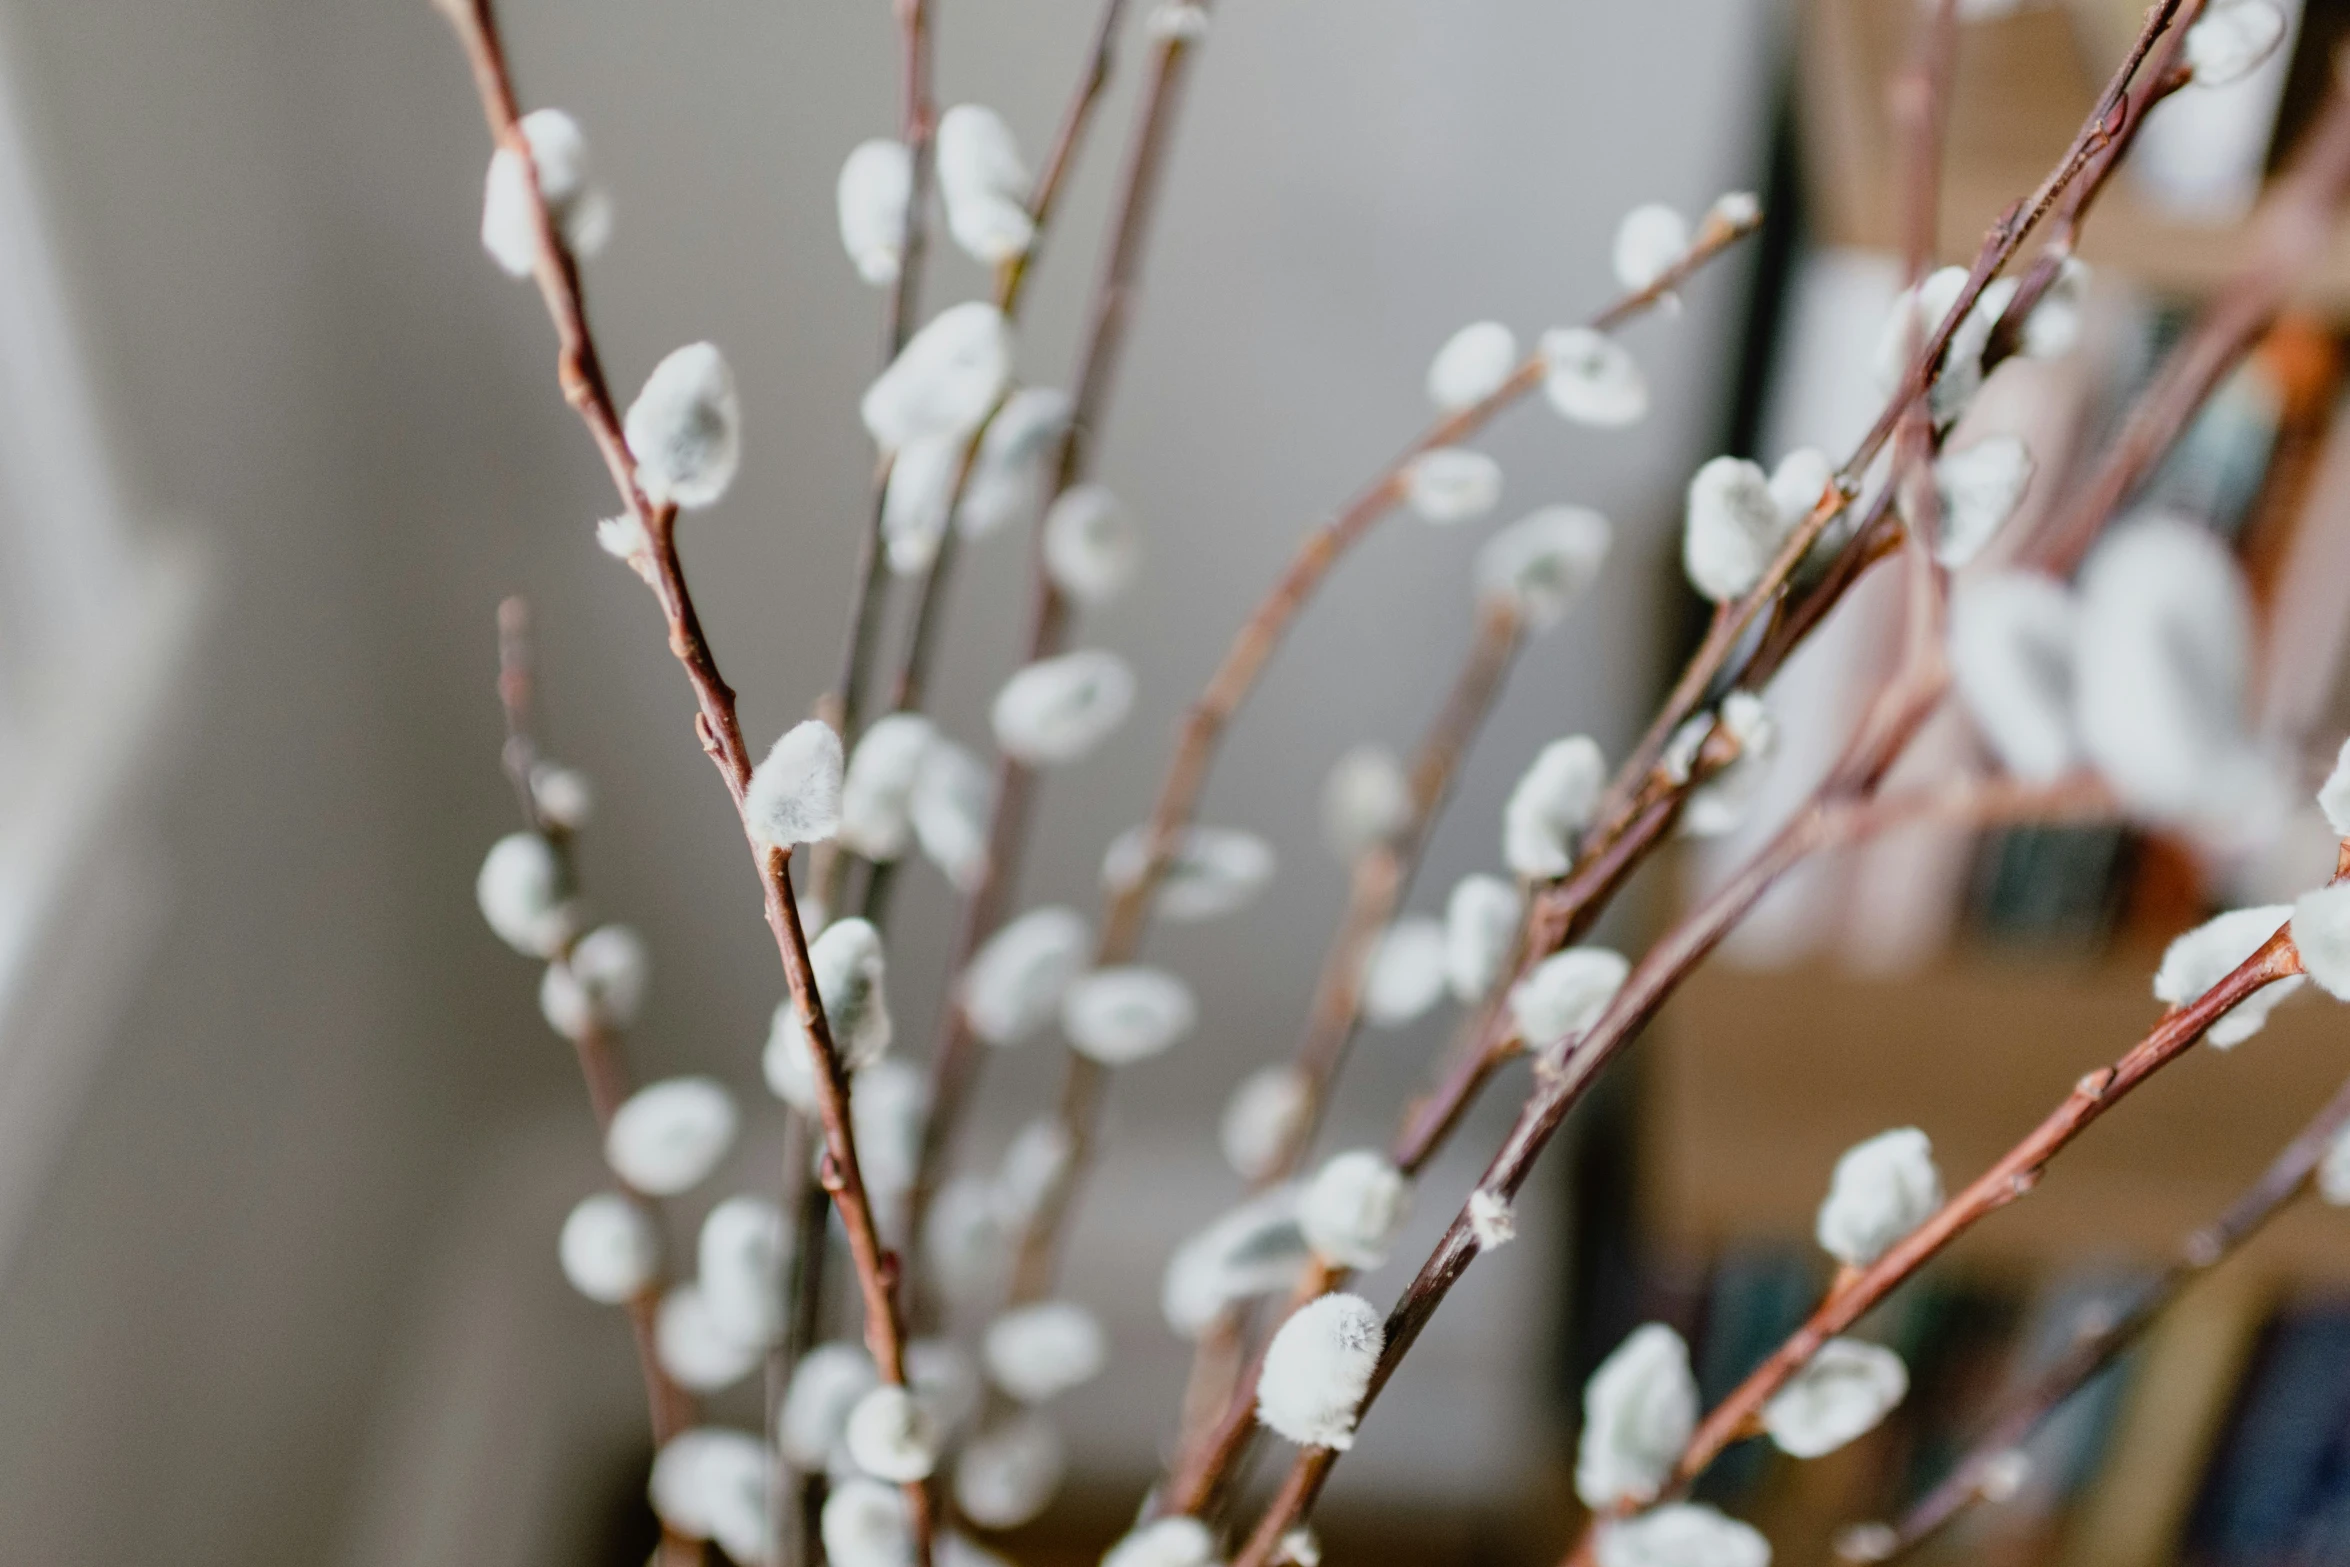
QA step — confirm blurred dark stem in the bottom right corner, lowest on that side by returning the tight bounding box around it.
[1866,1061,2350,1562]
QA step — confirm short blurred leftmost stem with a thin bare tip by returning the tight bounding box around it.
[481,599,703,1567]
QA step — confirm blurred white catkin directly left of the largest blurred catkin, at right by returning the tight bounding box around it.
[1951,571,2082,782]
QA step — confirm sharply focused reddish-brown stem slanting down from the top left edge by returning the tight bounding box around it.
[435,0,931,1567]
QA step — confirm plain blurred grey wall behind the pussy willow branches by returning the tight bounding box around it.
[0,0,1777,1565]
